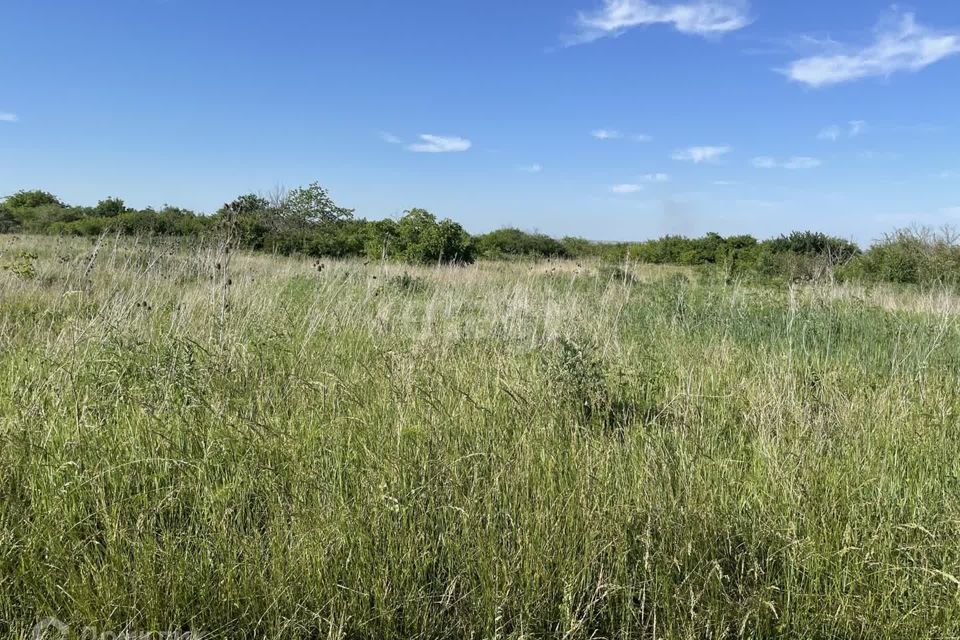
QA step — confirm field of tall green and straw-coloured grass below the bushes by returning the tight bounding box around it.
[0,236,960,639]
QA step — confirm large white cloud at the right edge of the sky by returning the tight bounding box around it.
[783,13,960,87]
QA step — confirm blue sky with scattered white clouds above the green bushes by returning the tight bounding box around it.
[0,0,960,242]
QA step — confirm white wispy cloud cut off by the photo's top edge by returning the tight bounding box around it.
[566,0,750,45]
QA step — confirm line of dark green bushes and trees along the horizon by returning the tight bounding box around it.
[0,183,960,284]
